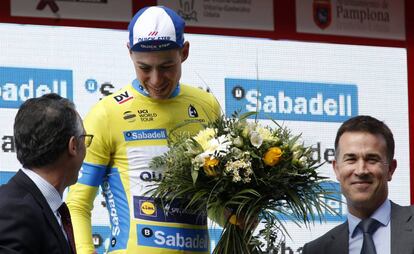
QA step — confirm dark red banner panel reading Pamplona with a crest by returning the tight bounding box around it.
[295,0,405,40]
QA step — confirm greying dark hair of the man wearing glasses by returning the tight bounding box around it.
[14,93,83,168]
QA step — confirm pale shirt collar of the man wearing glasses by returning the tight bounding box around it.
[22,169,63,213]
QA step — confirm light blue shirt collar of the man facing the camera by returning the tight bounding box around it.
[347,199,391,237]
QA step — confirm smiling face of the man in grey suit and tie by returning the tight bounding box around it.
[333,132,397,219]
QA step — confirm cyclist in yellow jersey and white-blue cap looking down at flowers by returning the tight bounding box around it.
[67,6,220,254]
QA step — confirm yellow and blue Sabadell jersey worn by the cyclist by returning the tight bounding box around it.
[67,80,221,254]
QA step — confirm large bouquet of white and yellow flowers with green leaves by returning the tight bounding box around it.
[151,113,329,253]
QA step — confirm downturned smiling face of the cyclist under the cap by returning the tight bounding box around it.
[130,42,189,99]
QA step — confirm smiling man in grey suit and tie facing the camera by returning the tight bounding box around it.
[303,116,414,254]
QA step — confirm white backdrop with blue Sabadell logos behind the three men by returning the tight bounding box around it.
[0,24,410,253]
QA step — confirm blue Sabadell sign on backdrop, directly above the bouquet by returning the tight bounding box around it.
[225,78,358,122]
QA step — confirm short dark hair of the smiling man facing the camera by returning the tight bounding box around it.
[335,115,395,162]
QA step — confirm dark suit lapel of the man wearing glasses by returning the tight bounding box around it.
[13,170,69,253]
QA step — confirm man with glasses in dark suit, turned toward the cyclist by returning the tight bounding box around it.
[0,94,92,254]
